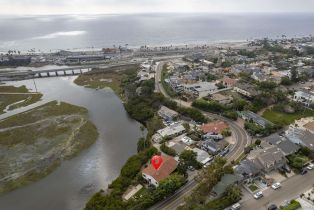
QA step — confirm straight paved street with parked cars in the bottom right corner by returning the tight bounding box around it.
[240,171,314,210]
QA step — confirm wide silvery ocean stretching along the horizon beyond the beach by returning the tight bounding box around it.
[0,14,314,51]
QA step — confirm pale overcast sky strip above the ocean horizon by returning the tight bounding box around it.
[0,0,314,15]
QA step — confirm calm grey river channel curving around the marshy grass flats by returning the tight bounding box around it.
[0,77,141,210]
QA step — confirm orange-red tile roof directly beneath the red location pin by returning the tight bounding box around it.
[142,155,178,182]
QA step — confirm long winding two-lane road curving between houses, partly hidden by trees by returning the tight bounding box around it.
[150,62,250,210]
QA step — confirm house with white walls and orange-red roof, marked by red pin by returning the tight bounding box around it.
[142,155,178,187]
